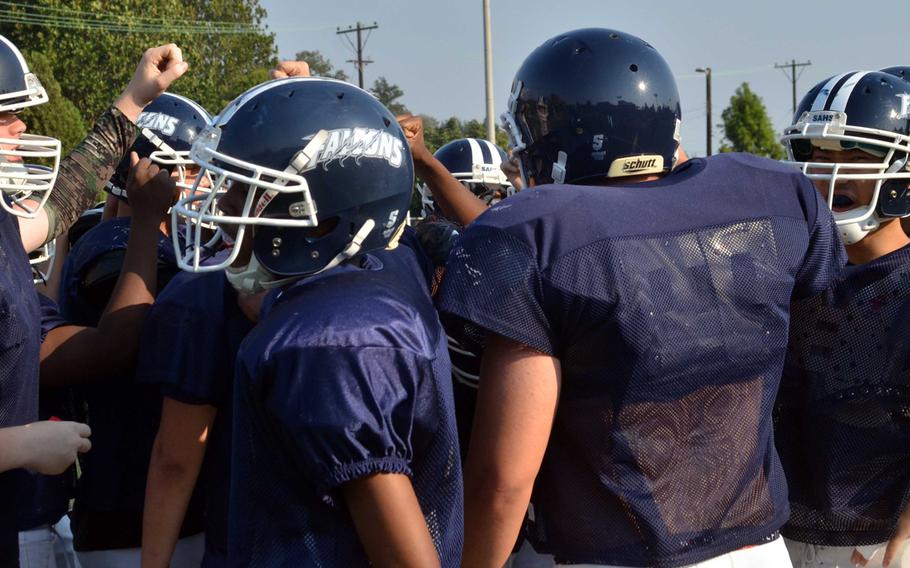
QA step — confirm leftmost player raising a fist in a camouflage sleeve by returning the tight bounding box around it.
[0,37,187,565]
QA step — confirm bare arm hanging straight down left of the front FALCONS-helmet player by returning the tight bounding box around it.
[142,400,217,568]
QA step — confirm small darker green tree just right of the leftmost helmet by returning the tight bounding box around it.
[22,52,86,155]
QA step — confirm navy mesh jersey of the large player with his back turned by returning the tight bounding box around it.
[439,154,845,566]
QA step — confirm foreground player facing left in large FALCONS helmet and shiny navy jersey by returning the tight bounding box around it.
[174,77,462,566]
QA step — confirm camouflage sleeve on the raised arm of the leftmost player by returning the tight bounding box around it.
[45,107,139,240]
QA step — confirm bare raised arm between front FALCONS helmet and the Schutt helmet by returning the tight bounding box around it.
[398,114,487,226]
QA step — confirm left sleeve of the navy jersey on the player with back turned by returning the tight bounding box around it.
[438,225,558,356]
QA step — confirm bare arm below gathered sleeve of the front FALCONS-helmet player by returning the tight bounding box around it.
[341,474,439,568]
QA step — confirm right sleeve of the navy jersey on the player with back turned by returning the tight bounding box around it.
[793,182,847,299]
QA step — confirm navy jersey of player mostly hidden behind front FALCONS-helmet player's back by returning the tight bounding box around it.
[137,264,253,567]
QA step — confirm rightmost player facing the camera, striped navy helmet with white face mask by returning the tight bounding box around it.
[775,71,910,568]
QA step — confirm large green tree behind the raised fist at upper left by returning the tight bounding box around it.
[0,0,275,119]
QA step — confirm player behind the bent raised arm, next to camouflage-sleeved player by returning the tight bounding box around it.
[60,93,211,568]
